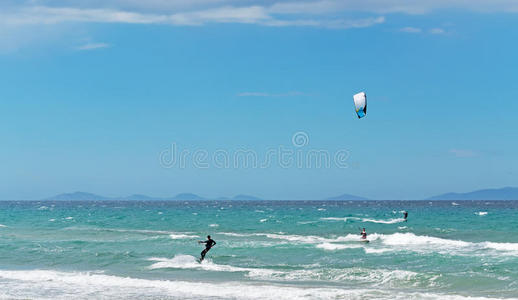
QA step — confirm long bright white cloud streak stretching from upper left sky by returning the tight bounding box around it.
[0,6,385,29]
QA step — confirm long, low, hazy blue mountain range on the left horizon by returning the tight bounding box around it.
[45,192,262,201]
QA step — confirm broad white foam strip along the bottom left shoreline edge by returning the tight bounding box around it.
[0,270,363,299]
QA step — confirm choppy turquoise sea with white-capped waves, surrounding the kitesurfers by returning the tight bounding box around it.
[0,201,518,299]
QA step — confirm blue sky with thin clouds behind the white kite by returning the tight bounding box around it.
[0,0,518,200]
